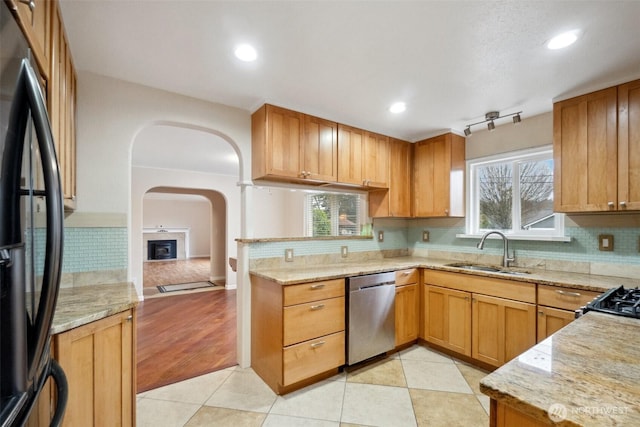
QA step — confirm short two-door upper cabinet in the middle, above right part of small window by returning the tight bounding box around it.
[338,124,389,188]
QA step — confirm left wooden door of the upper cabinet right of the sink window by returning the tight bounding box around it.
[553,87,618,212]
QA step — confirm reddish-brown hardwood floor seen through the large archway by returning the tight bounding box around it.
[137,260,237,393]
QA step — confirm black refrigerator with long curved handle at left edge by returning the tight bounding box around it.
[0,1,67,427]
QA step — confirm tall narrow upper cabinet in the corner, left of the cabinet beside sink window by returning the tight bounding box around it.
[369,138,413,218]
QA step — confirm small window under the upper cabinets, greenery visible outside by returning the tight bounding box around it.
[305,192,369,237]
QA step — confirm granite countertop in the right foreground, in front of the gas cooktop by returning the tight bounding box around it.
[480,312,640,427]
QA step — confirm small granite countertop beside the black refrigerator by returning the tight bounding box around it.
[51,283,138,334]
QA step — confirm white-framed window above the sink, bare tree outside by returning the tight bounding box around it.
[467,147,564,238]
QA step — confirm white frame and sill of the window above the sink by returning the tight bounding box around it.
[457,145,570,241]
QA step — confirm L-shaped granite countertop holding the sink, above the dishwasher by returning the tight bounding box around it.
[250,256,639,292]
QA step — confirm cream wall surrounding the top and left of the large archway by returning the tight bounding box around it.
[77,72,251,216]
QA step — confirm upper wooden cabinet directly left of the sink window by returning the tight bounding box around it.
[413,133,465,217]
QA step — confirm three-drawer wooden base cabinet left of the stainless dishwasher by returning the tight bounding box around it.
[251,275,345,394]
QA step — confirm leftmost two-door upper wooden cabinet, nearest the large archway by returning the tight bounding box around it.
[251,104,338,182]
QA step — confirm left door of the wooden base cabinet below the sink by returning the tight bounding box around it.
[424,285,471,356]
